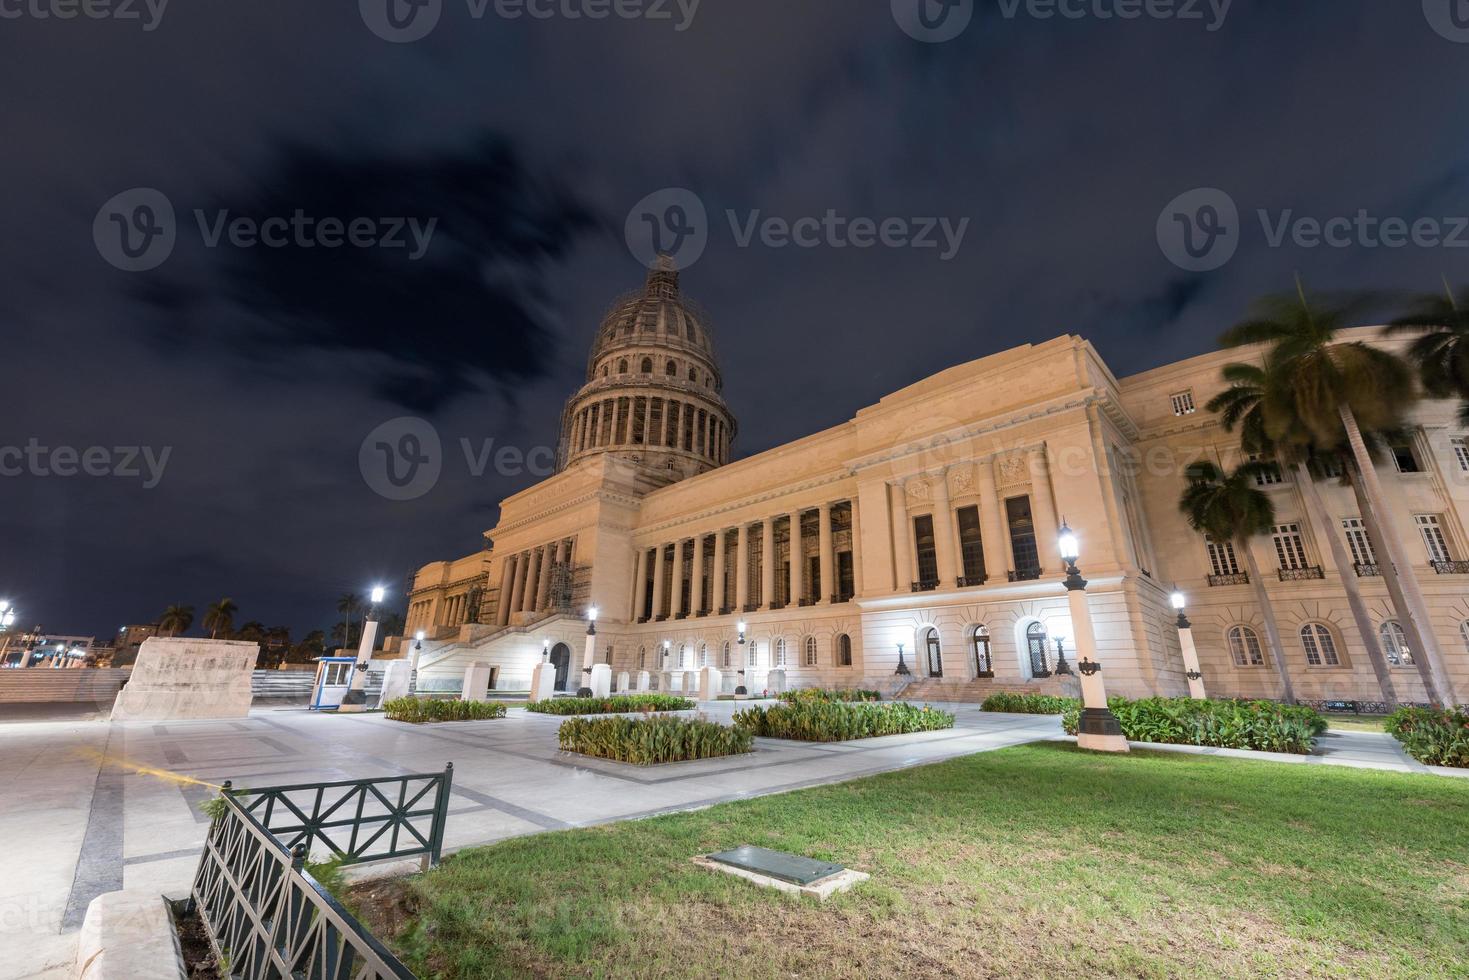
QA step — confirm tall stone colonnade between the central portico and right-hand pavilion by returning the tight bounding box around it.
[633,501,861,619]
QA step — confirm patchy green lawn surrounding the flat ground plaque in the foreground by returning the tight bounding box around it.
[351,743,1469,977]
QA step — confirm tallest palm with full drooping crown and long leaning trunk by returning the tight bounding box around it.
[1219,287,1453,704]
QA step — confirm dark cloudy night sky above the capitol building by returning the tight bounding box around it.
[0,0,1469,636]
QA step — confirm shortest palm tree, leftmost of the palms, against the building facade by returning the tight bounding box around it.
[1178,460,1296,704]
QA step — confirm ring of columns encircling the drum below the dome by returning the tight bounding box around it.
[570,395,729,463]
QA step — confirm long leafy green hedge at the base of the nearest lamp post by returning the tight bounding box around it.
[1061,698,1327,755]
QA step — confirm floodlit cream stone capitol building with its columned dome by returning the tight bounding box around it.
[407,260,1469,701]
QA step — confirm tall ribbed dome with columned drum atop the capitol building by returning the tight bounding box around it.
[561,257,736,479]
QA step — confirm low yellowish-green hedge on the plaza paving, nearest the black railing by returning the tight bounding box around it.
[557,717,754,765]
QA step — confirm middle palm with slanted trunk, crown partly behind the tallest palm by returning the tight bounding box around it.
[1206,364,1398,711]
